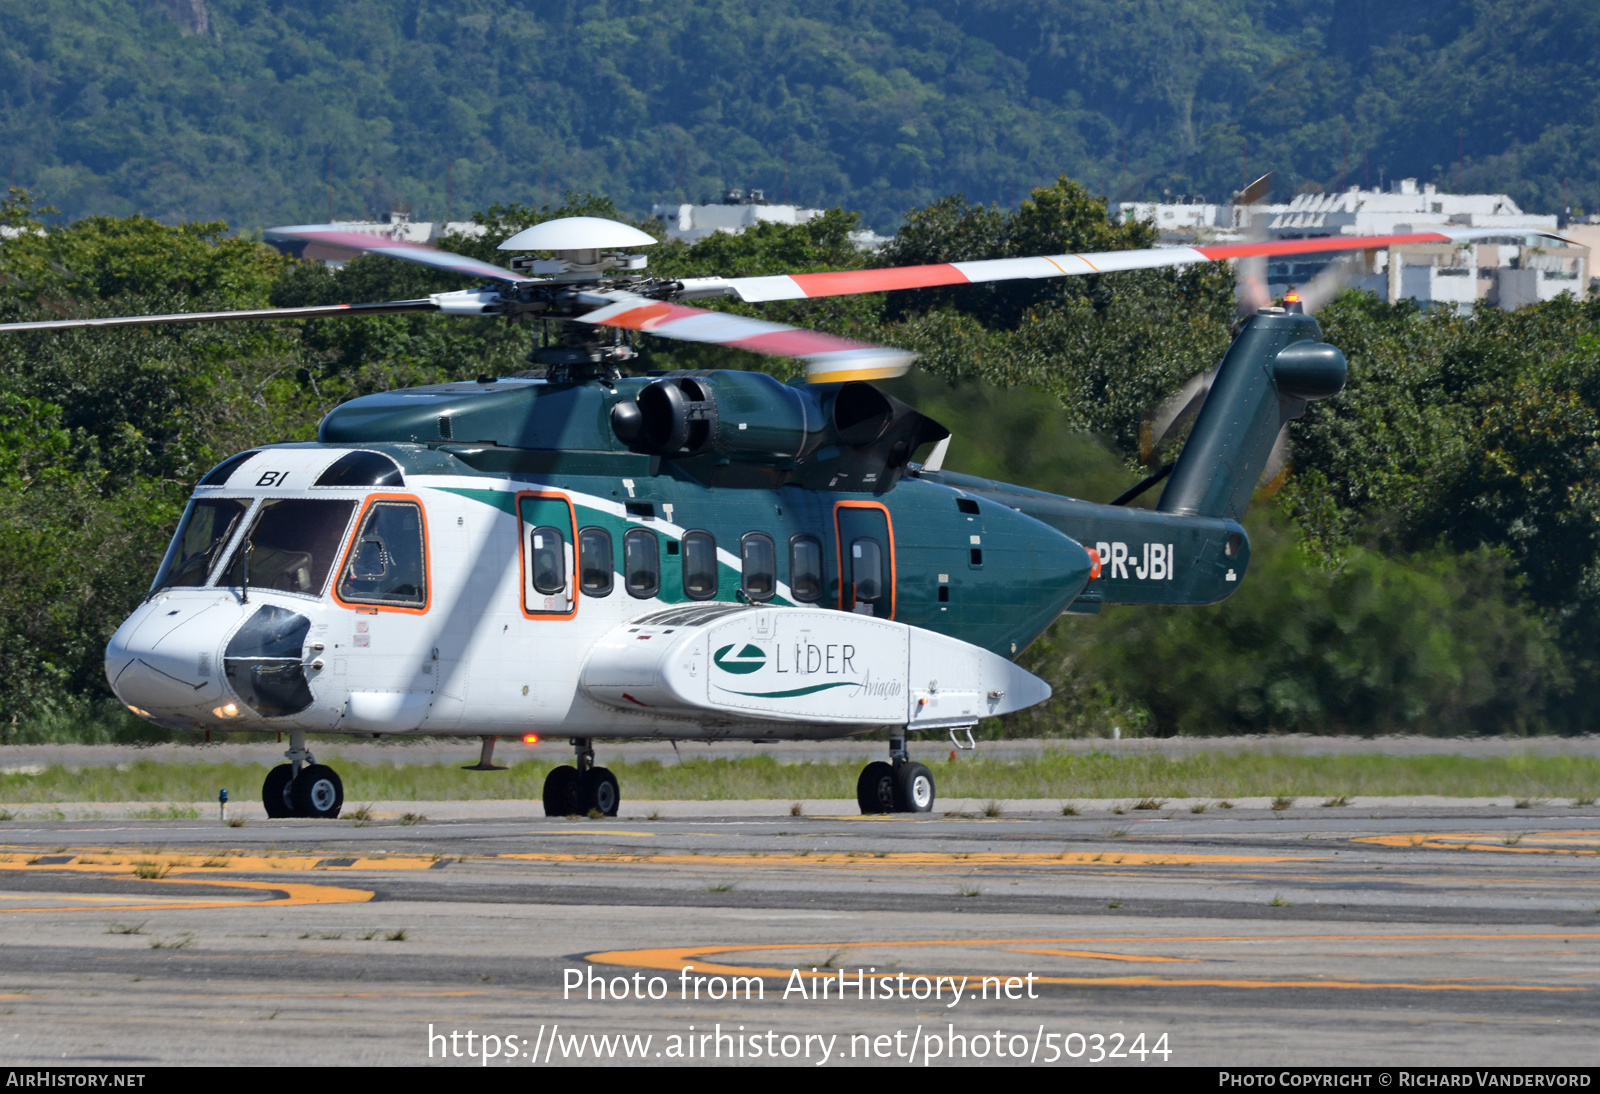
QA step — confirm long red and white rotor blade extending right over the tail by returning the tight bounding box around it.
[683,229,1563,304]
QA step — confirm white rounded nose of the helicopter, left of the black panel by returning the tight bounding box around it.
[106,597,243,720]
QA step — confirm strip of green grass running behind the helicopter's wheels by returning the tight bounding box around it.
[0,752,1600,802]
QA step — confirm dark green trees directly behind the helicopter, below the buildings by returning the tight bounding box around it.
[0,179,1600,741]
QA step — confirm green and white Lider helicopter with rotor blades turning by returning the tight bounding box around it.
[0,218,1555,817]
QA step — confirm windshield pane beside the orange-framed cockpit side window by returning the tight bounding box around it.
[226,497,355,597]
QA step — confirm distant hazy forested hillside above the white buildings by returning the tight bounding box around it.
[0,0,1600,230]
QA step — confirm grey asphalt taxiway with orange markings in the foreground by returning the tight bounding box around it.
[0,801,1600,1067]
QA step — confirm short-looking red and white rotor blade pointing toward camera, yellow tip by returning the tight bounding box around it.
[579,293,917,384]
